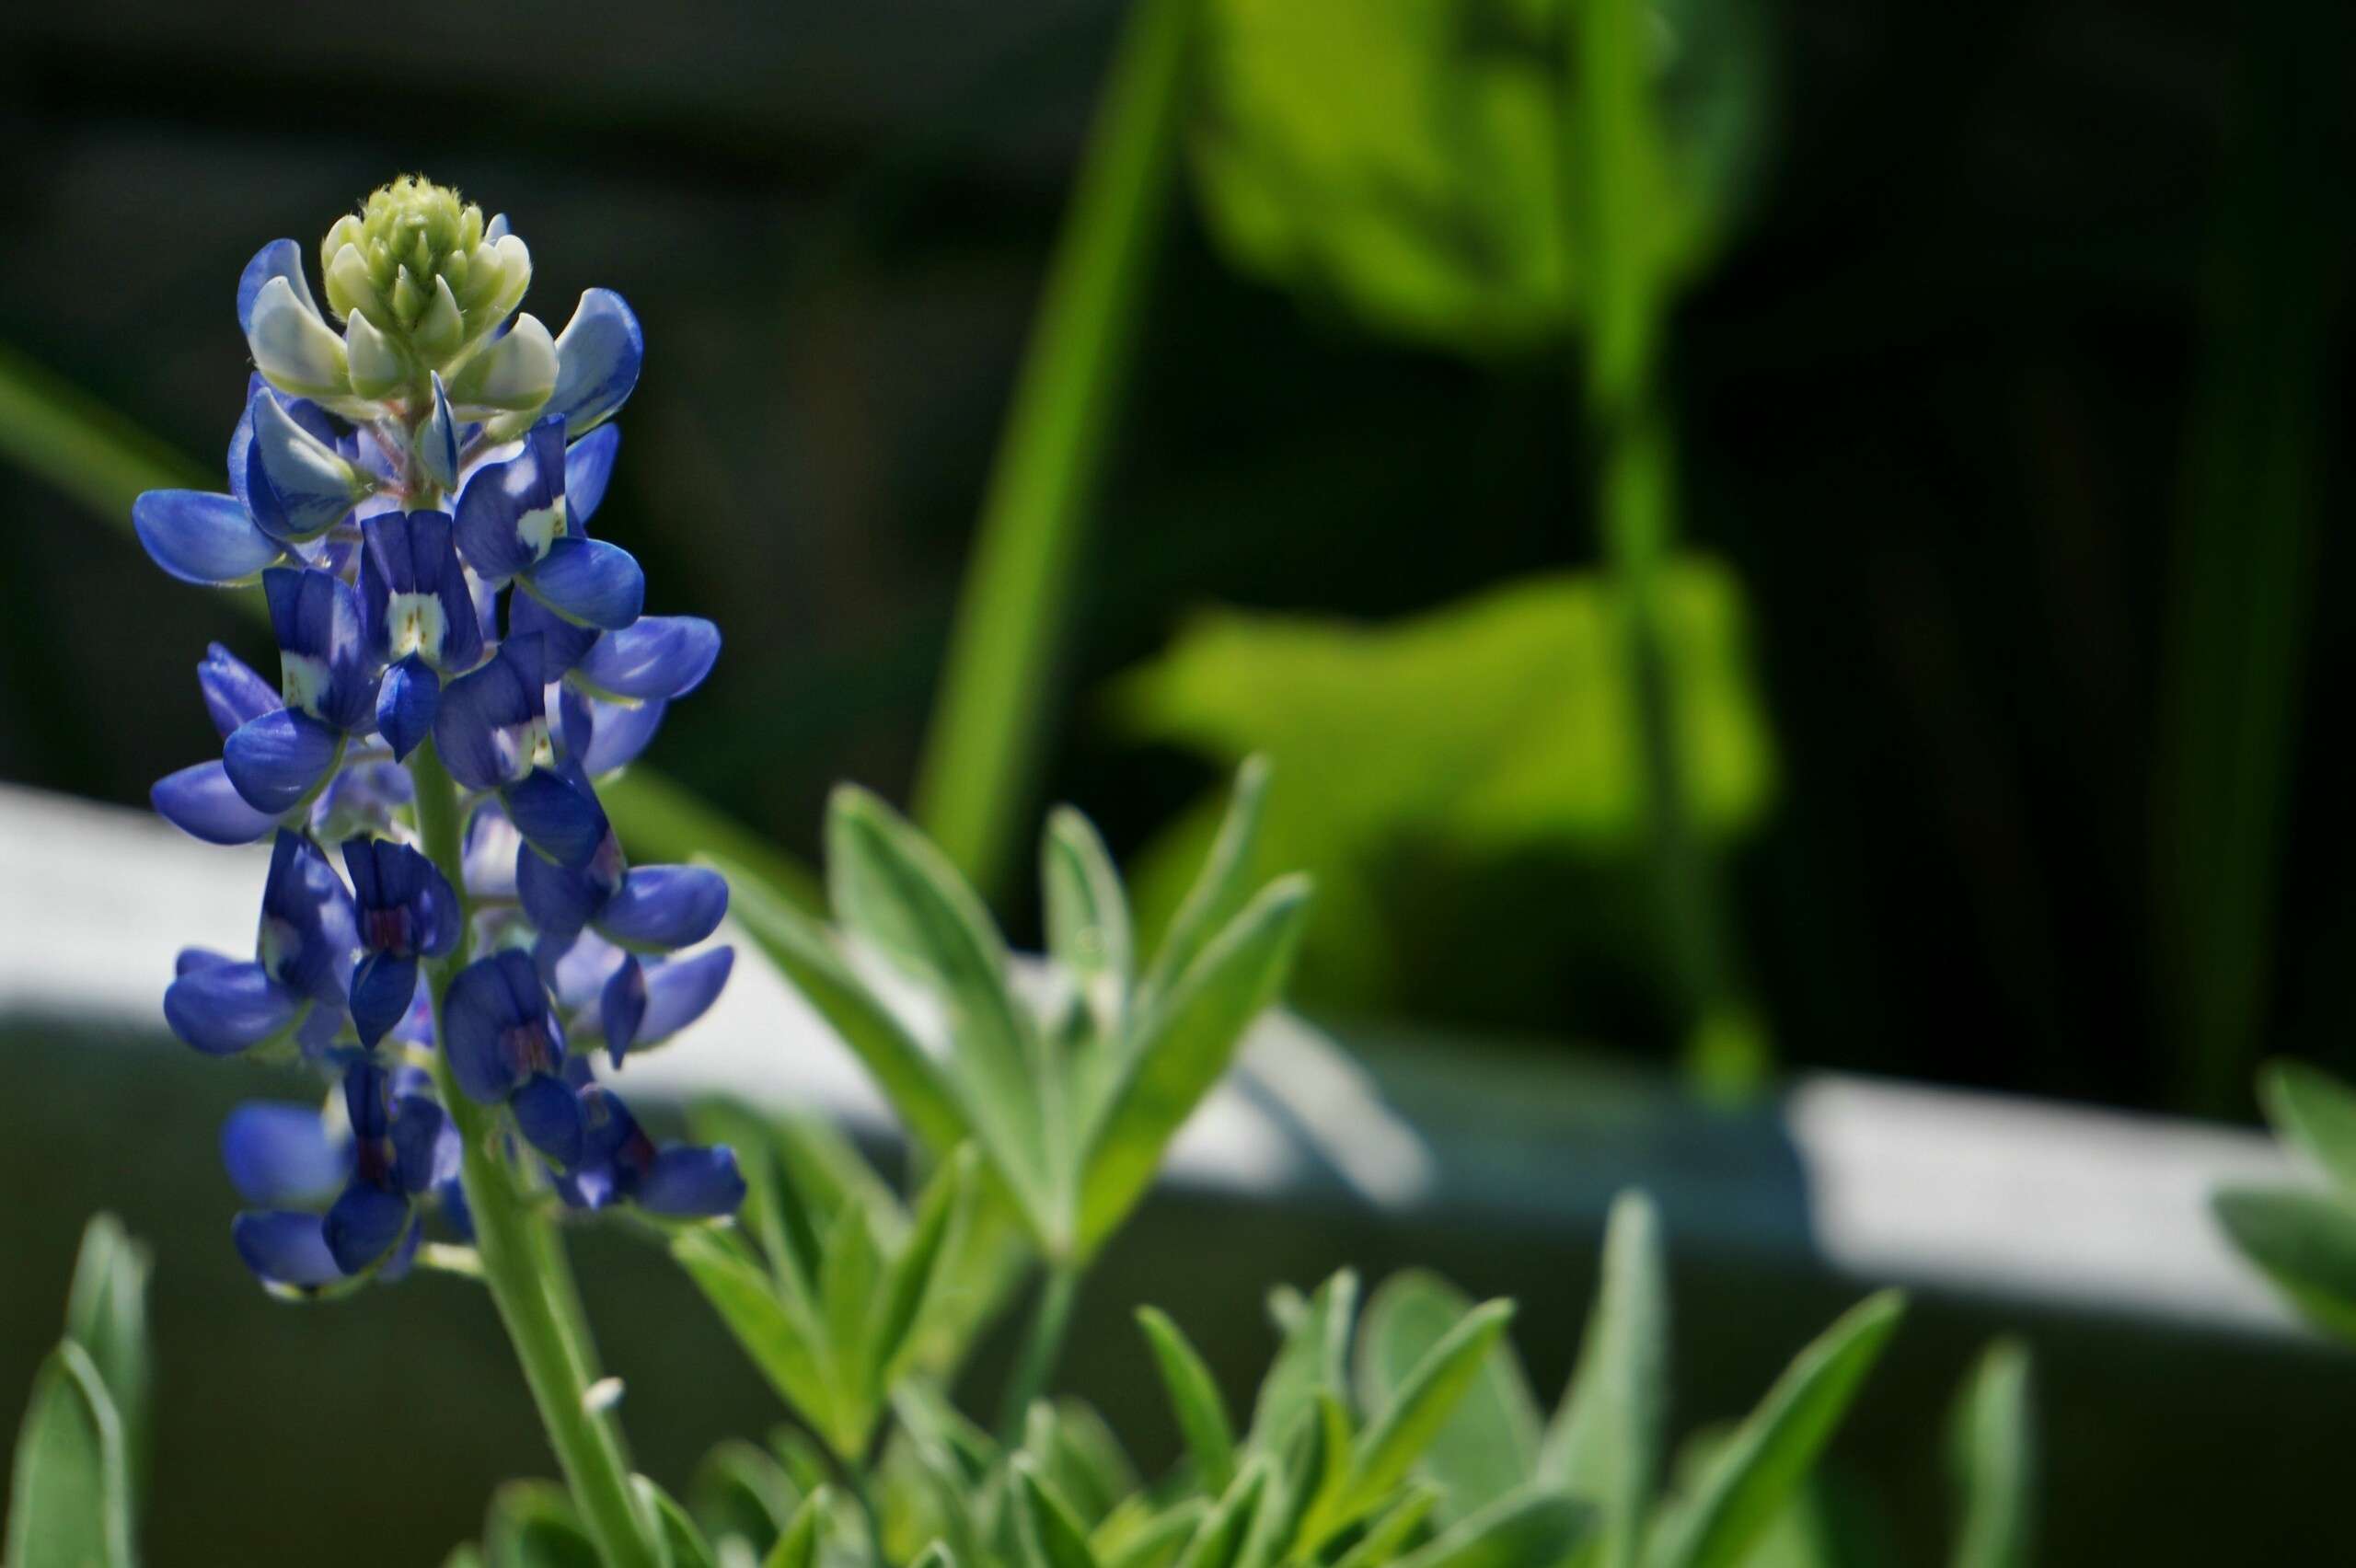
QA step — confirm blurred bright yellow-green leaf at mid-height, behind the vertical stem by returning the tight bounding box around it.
[1114,567,1774,1006]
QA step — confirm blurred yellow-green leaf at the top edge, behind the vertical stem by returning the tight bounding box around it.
[1195,0,1767,353]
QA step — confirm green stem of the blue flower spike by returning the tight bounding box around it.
[410,742,660,1568]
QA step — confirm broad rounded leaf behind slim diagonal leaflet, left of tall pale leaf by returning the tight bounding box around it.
[1357,1269,1539,1521]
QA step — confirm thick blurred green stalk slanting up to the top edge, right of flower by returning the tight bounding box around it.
[914,0,1199,897]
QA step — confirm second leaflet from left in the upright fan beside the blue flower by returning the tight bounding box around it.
[827,787,1065,1252]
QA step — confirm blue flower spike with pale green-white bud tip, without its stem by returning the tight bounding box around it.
[132,177,745,1293]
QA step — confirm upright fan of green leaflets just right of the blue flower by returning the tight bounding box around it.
[725,770,1308,1264]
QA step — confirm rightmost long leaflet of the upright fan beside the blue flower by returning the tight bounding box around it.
[1079,876,1310,1257]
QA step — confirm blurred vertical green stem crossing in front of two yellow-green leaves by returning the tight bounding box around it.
[1565,0,1772,1095]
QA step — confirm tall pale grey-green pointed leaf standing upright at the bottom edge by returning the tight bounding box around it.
[1539,1192,1668,1568]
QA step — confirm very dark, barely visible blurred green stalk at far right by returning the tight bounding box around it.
[2151,7,2339,1113]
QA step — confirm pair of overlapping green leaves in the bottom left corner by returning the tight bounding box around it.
[5,1215,151,1568]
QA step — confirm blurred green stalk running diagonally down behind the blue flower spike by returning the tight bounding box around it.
[0,336,825,911]
